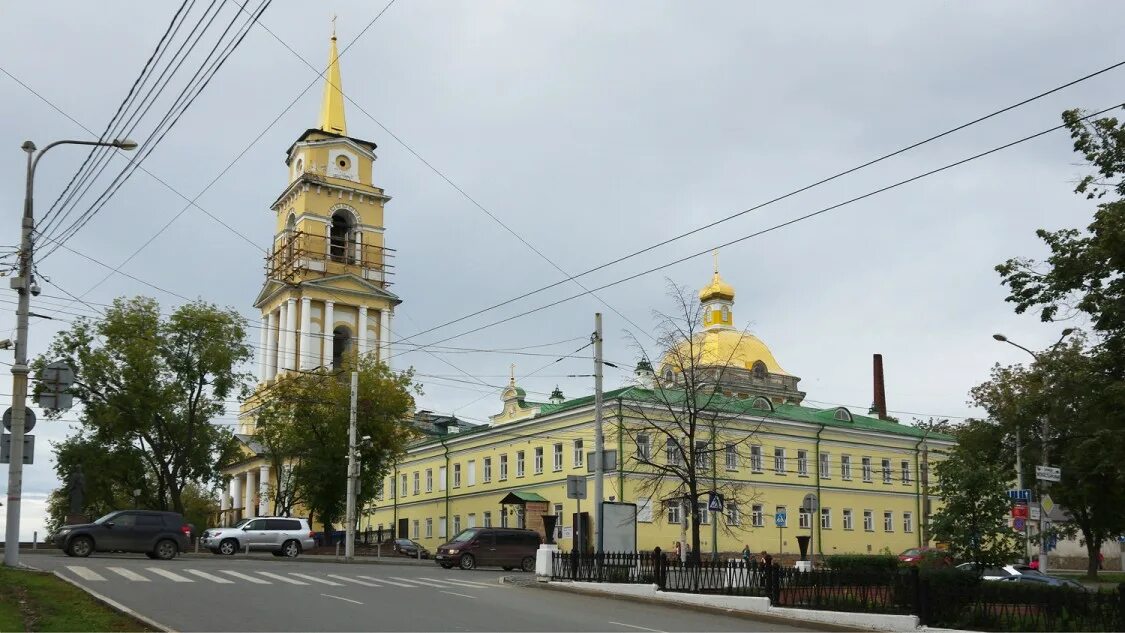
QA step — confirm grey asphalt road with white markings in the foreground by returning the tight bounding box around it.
[23,552,807,633]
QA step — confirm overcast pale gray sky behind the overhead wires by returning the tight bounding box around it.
[0,0,1125,537]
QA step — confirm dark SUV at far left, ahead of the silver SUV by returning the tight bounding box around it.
[52,510,191,560]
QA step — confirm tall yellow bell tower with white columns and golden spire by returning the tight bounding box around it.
[222,30,402,523]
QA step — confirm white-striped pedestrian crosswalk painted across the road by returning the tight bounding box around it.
[66,564,500,590]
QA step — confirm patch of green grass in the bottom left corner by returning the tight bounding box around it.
[0,567,151,631]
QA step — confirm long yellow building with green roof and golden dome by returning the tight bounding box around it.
[361,270,952,554]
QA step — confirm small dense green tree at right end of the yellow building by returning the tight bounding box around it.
[930,423,1023,569]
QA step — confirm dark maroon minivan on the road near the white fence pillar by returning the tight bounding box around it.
[434,527,540,571]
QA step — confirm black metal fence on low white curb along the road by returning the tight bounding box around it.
[551,549,1125,631]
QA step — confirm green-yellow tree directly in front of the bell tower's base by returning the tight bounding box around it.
[255,359,420,530]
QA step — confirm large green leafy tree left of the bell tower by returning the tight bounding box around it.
[34,297,252,513]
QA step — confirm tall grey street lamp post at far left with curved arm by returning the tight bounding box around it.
[3,139,137,567]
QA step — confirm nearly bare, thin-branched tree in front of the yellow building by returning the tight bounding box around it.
[621,280,761,560]
